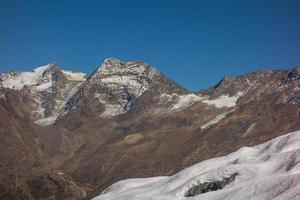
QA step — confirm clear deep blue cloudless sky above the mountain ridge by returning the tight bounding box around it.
[0,0,300,91]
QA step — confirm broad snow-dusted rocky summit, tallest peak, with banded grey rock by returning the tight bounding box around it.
[84,58,159,117]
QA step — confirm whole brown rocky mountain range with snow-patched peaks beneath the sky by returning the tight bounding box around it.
[0,59,300,199]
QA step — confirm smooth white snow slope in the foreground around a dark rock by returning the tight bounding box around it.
[94,131,300,200]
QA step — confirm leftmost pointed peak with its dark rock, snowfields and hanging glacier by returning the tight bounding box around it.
[0,62,86,125]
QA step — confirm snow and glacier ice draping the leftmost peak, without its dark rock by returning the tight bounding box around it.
[0,63,86,126]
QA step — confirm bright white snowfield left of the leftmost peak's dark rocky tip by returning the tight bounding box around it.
[1,64,52,90]
